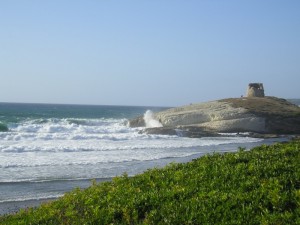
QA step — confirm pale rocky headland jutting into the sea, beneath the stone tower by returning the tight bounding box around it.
[129,97,300,137]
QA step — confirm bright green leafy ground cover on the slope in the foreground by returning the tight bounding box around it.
[0,140,300,224]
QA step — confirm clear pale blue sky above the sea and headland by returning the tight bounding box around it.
[0,0,300,106]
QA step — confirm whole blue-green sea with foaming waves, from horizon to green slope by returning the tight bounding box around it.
[0,99,300,214]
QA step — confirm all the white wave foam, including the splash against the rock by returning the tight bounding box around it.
[0,115,260,185]
